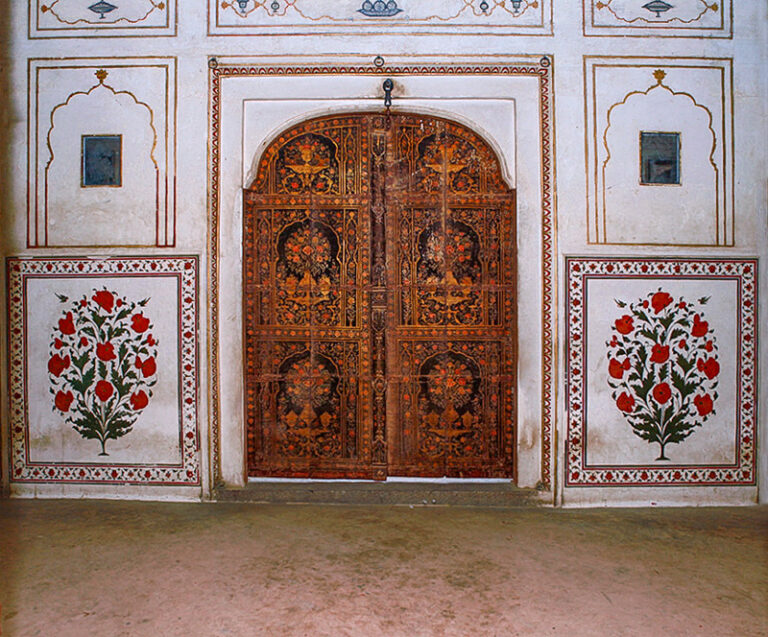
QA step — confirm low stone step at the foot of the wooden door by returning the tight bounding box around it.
[214,480,551,508]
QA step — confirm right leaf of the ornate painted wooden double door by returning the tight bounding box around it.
[387,115,515,477]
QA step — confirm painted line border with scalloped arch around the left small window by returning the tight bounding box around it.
[27,58,178,248]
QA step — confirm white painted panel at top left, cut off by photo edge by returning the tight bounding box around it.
[29,0,176,38]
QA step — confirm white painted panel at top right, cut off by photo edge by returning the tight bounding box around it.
[583,0,733,38]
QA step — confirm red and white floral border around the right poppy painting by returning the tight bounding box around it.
[565,257,757,487]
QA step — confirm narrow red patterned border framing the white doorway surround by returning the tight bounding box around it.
[208,56,556,490]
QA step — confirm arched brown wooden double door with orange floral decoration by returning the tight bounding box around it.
[243,113,517,479]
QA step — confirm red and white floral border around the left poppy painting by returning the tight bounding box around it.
[6,256,200,486]
